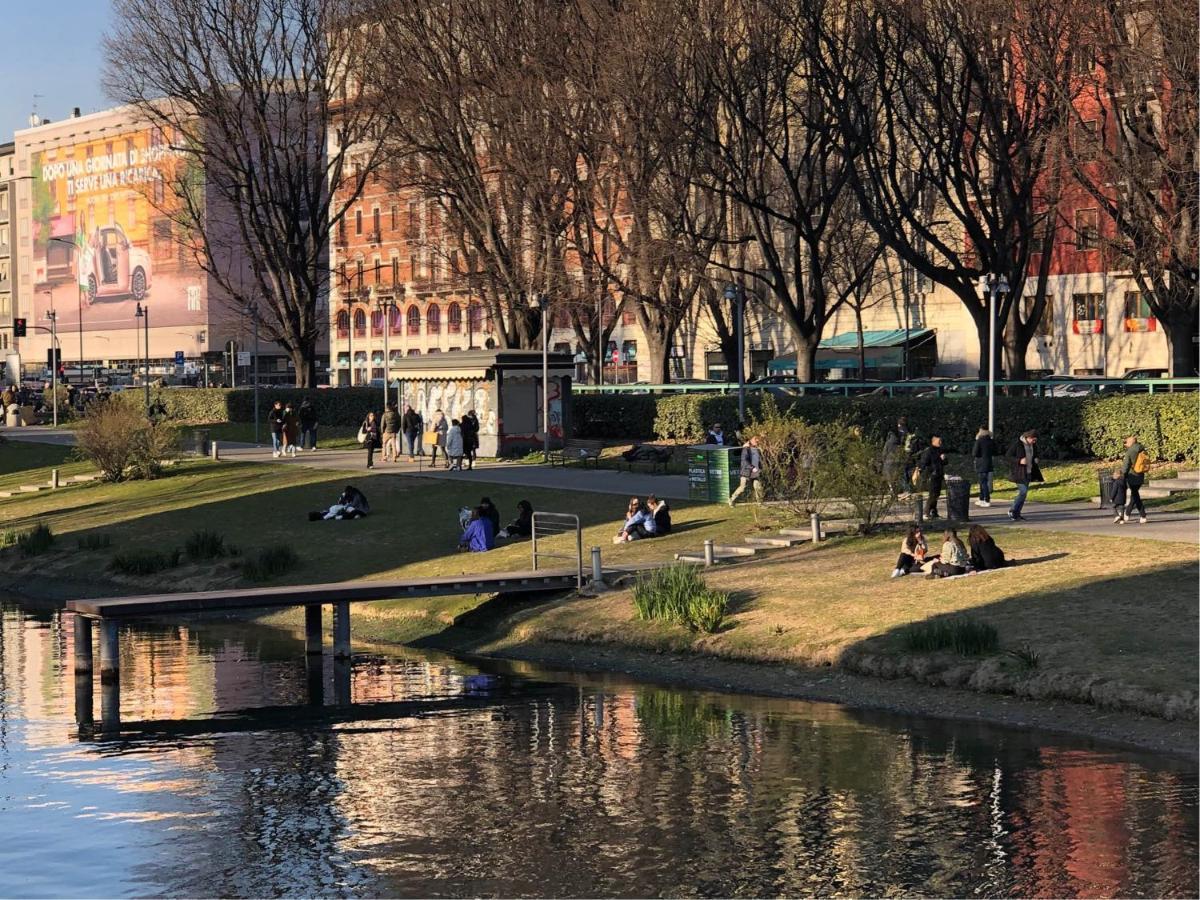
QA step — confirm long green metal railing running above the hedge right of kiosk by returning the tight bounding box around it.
[571,378,1200,397]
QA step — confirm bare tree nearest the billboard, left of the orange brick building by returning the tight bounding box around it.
[104,0,379,386]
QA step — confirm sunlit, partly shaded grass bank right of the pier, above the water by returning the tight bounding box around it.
[492,528,1200,718]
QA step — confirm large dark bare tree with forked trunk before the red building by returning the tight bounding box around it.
[815,0,1075,378]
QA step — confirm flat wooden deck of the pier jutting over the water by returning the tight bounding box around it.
[67,569,578,619]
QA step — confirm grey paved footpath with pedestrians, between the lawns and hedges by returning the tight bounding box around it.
[0,427,1200,544]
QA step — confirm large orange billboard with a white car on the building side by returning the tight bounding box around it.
[30,128,208,331]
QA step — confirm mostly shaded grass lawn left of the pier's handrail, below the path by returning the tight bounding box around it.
[0,458,755,618]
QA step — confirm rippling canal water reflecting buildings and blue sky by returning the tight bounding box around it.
[0,602,1198,896]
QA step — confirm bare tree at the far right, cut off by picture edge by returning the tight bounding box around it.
[1058,0,1200,377]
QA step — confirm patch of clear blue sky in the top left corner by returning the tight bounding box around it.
[0,0,111,143]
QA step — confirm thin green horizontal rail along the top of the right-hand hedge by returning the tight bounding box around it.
[571,378,1200,397]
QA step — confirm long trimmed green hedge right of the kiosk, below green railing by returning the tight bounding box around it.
[574,394,1198,461]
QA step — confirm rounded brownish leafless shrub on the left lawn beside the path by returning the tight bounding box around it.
[76,403,179,481]
